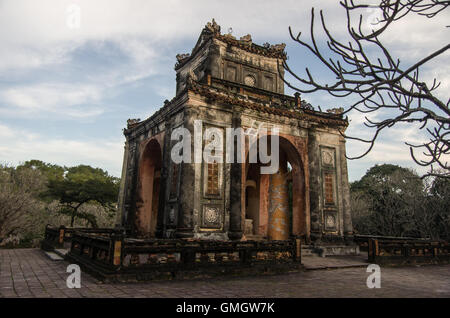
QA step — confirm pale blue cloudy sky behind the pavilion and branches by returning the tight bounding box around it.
[0,0,450,180]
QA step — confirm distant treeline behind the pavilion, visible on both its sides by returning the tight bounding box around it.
[0,160,450,246]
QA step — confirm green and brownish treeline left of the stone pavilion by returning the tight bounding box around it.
[0,160,120,246]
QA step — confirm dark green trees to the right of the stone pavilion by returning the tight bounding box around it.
[351,164,450,240]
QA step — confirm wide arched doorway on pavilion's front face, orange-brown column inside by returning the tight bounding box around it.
[243,136,309,240]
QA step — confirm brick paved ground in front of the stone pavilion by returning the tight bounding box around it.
[0,249,450,297]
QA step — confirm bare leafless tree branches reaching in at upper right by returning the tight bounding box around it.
[283,0,450,178]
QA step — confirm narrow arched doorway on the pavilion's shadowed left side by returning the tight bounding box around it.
[136,139,162,237]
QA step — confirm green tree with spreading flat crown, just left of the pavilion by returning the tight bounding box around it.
[45,165,119,228]
